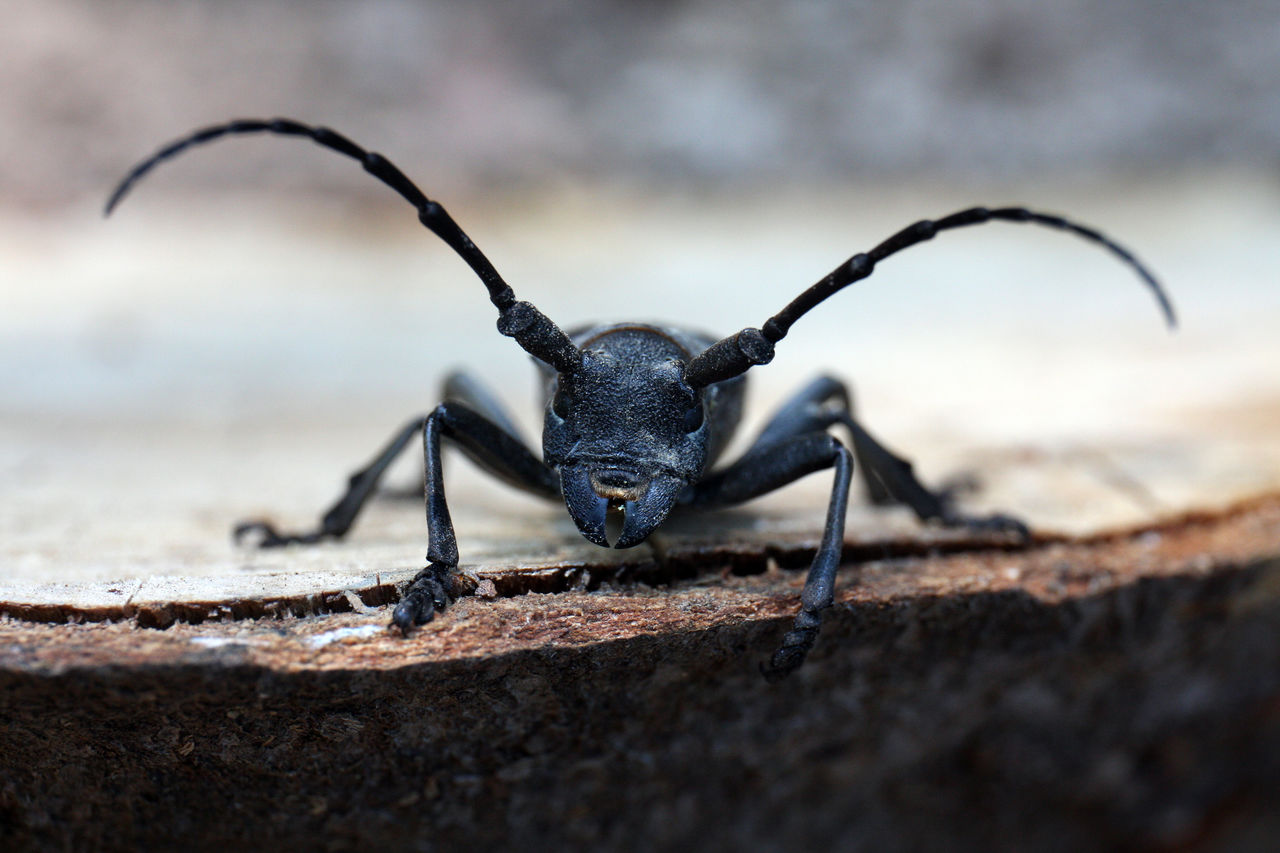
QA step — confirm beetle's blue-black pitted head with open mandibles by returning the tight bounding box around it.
[543,330,708,548]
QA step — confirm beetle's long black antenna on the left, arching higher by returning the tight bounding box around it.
[104,118,582,373]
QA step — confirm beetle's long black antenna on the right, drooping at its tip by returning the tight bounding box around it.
[685,207,1178,388]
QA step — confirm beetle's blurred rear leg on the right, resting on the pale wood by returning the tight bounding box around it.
[748,377,1030,539]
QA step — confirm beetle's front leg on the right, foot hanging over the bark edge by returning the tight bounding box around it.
[691,433,854,681]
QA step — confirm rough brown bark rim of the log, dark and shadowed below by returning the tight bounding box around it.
[0,497,1280,850]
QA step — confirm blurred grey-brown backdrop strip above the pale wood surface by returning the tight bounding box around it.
[0,0,1280,199]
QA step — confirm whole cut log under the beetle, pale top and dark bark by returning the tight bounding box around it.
[0,187,1280,850]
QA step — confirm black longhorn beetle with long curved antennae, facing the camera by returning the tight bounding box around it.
[106,119,1175,680]
